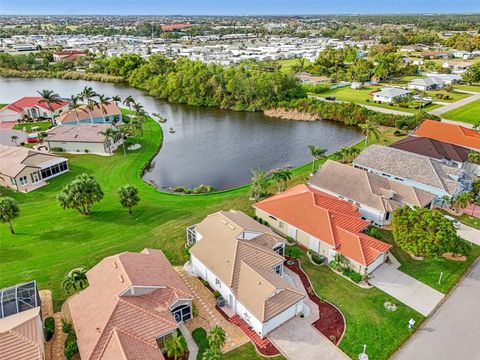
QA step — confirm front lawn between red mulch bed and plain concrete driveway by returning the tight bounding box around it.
[300,250,424,360]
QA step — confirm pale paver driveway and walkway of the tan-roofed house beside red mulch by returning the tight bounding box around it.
[268,269,350,360]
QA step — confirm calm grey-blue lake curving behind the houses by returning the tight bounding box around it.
[0,77,363,189]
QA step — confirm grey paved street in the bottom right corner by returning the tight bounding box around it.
[392,260,480,360]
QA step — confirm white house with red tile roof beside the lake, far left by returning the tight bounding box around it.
[0,96,68,123]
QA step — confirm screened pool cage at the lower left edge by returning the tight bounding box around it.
[0,280,41,319]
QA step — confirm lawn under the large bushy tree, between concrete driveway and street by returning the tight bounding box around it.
[379,229,480,294]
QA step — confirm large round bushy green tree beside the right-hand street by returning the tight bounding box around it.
[392,206,469,257]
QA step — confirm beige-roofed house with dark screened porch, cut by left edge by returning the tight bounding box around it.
[0,144,68,192]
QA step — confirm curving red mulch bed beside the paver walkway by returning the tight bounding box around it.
[286,259,345,344]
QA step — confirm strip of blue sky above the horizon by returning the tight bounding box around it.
[0,0,480,15]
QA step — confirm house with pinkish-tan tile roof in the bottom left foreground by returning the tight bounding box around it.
[68,249,193,360]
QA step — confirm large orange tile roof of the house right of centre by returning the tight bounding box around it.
[254,184,391,266]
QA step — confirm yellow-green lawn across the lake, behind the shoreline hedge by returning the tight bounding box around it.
[312,86,440,113]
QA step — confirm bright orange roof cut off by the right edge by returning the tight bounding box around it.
[415,120,480,151]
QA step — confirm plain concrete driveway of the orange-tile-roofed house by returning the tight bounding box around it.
[370,255,445,316]
